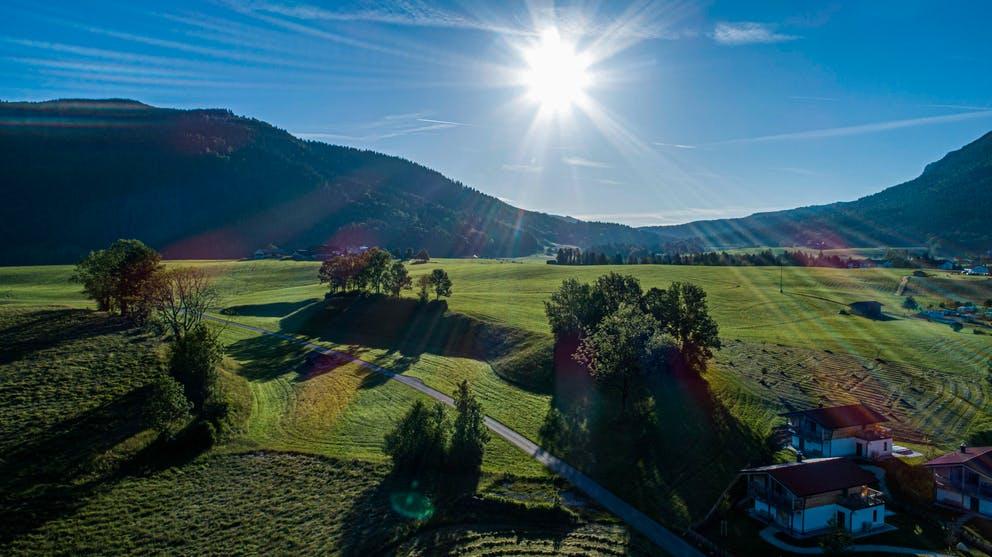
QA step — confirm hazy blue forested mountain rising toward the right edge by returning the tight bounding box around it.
[647,132,992,253]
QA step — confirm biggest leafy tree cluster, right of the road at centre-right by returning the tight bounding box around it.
[544,273,720,412]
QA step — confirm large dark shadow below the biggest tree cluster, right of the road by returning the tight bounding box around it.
[539,338,772,526]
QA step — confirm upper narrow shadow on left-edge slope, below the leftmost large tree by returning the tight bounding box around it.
[0,309,129,365]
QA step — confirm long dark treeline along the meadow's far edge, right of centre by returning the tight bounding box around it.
[548,248,940,269]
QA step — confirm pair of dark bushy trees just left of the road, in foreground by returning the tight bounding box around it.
[385,381,489,475]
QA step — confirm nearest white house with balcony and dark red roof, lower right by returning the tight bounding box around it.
[741,458,891,538]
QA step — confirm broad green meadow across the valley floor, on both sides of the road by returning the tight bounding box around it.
[0,259,992,547]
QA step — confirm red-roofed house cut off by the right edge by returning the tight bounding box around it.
[924,443,992,517]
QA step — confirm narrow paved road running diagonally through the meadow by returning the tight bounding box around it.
[204,315,703,557]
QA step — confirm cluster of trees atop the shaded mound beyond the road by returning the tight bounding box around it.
[317,248,451,301]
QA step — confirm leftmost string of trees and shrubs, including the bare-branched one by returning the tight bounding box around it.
[72,240,225,436]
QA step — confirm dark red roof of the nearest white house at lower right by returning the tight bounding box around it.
[742,457,876,497]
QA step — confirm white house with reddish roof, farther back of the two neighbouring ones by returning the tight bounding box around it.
[782,404,892,460]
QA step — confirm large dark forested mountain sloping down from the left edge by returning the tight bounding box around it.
[0,99,658,265]
